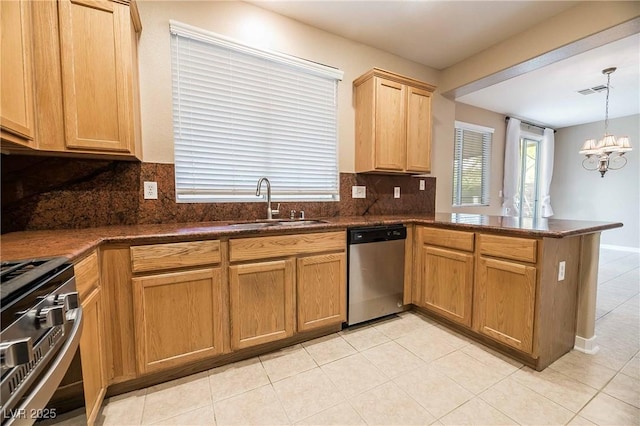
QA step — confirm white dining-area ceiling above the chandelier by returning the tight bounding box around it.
[456,34,640,129]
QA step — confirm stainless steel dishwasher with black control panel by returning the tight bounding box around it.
[347,224,407,325]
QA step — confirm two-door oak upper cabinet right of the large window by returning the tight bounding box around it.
[353,68,435,173]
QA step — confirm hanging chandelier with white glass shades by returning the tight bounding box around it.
[580,67,632,177]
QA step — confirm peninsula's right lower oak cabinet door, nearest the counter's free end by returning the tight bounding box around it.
[475,256,536,353]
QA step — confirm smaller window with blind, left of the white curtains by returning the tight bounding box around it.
[453,121,493,206]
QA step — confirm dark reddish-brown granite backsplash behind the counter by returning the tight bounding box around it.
[1,155,436,233]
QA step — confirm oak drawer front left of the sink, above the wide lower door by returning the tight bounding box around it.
[131,240,220,272]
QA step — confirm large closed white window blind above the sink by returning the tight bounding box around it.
[170,21,342,202]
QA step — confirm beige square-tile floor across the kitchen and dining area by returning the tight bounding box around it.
[51,250,640,425]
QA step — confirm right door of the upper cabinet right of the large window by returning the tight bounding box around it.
[407,86,431,173]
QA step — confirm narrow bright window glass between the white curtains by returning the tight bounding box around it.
[516,137,540,217]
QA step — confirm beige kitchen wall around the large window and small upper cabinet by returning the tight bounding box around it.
[138,1,454,176]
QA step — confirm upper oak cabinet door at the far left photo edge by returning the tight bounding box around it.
[0,1,34,144]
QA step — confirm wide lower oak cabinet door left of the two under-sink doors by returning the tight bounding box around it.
[132,268,223,373]
